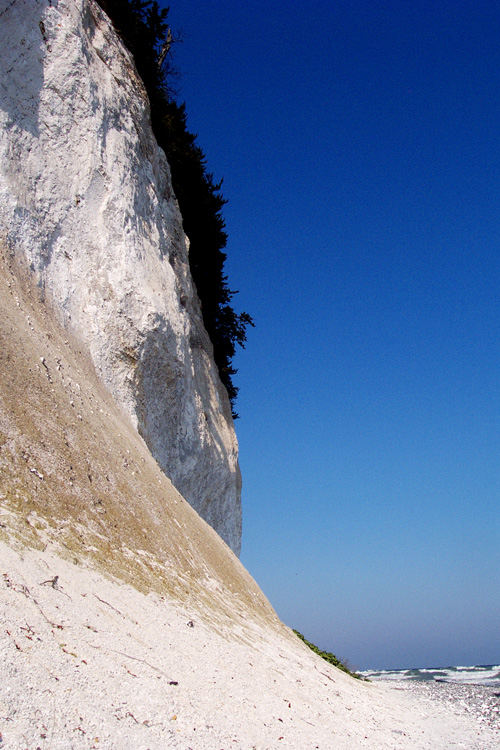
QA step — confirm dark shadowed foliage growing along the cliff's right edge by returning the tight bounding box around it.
[99,0,253,417]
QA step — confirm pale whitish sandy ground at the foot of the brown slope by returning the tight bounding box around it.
[0,543,500,750]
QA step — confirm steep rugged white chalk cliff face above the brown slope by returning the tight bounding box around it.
[0,0,241,553]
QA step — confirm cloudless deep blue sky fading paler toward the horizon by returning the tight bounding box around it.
[162,0,500,668]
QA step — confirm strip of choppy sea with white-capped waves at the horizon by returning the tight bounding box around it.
[359,664,500,690]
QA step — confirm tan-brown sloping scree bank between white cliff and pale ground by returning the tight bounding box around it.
[0,243,278,637]
